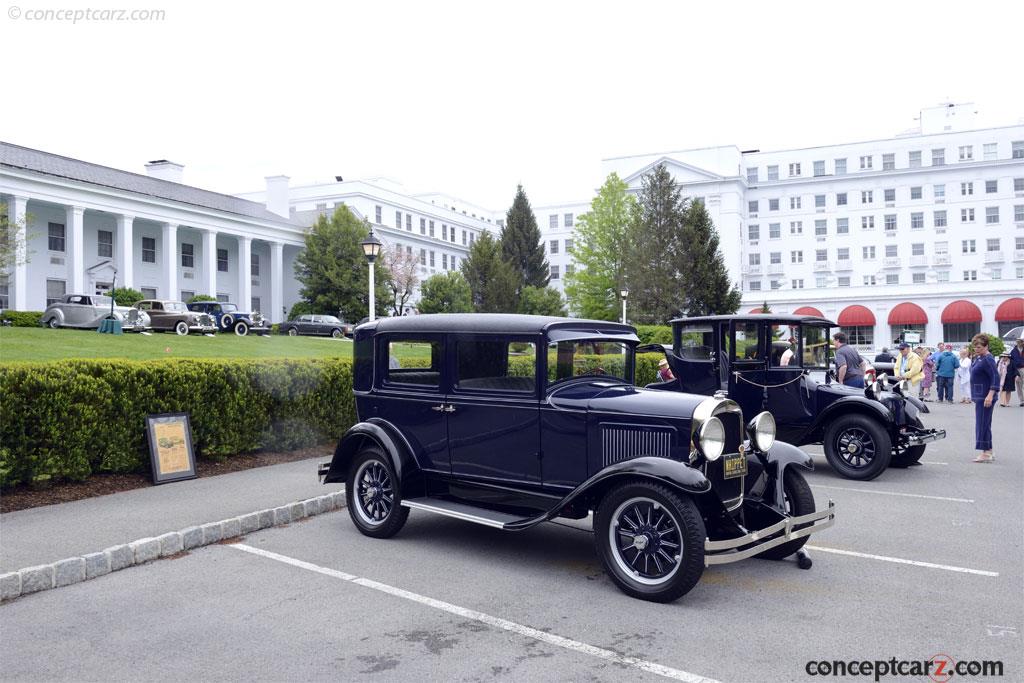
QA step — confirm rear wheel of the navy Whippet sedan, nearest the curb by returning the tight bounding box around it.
[345,444,409,539]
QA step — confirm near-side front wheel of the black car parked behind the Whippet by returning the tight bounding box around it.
[823,415,893,481]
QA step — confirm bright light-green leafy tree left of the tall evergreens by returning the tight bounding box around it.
[565,173,637,321]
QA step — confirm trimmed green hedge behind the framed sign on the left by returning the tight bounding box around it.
[0,358,355,485]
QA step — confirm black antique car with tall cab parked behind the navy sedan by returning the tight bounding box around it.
[650,313,946,480]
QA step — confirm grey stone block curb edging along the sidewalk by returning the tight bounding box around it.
[0,490,345,602]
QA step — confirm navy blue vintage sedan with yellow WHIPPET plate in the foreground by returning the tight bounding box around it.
[318,313,835,602]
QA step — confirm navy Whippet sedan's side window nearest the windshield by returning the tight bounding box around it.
[456,338,537,393]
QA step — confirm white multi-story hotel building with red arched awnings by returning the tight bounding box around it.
[538,104,1024,347]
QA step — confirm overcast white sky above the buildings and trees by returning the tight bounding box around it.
[0,0,1024,210]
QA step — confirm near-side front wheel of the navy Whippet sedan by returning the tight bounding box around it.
[594,482,707,602]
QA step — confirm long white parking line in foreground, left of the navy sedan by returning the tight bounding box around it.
[227,543,718,683]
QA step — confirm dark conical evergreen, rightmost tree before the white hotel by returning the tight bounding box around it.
[680,197,742,315]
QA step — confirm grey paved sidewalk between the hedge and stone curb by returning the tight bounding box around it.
[0,458,342,573]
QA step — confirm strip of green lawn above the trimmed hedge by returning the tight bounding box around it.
[0,328,352,362]
